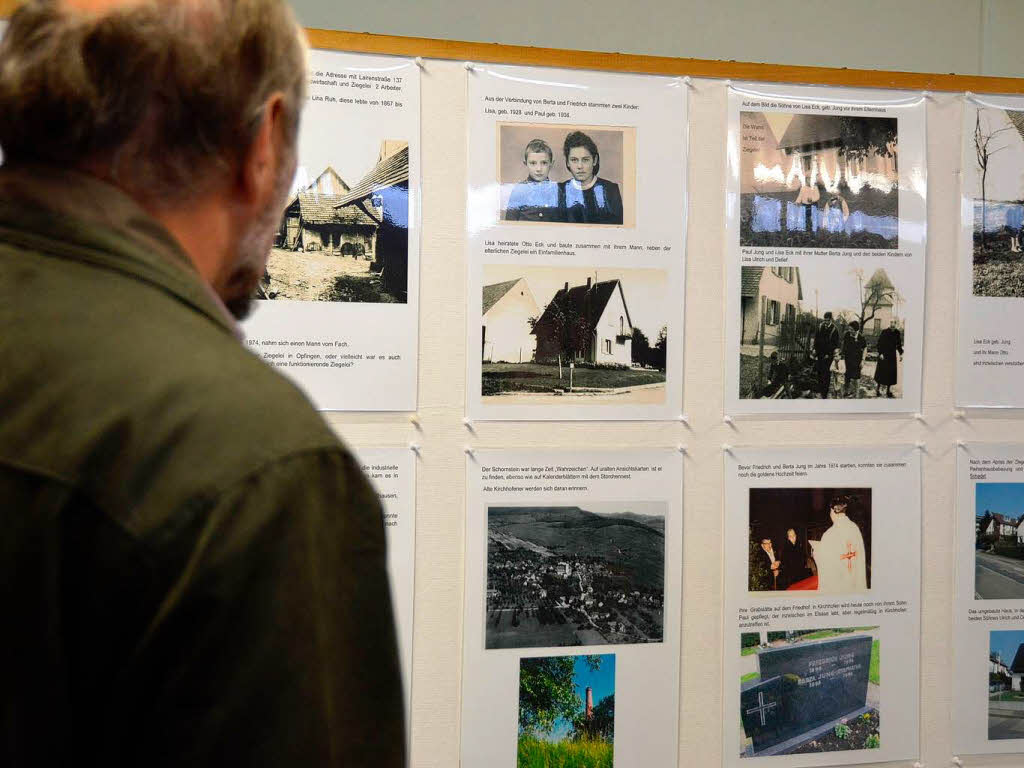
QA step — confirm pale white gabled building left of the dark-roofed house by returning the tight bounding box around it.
[480,278,541,362]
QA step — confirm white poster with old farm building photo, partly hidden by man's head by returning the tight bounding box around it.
[244,50,420,411]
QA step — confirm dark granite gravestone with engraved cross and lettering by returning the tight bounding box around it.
[739,635,872,753]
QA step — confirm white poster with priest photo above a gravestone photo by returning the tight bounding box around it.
[722,445,921,768]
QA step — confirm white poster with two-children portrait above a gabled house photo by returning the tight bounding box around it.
[466,65,687,420]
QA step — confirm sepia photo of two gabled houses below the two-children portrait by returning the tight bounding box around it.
[480,264,669,408]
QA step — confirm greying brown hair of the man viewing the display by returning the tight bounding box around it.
[0,0,307,202]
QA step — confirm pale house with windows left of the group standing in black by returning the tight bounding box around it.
[739,266,804,345]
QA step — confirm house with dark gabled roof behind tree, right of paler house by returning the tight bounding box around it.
[534,278,633,366]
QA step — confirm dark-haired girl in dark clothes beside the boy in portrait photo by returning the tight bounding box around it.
[558,131,623,224]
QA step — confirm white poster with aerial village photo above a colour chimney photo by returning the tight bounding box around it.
[462,450,683,768]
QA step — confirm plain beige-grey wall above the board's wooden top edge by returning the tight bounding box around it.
[293,0,1024,77]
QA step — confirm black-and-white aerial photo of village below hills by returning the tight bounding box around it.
[485,502,665,648]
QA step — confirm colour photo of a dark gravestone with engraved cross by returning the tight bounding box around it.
[739,627,882,758]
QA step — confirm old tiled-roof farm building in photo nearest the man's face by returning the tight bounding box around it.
[278,166,380,259]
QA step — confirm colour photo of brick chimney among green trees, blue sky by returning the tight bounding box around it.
[516,653,615,768]
